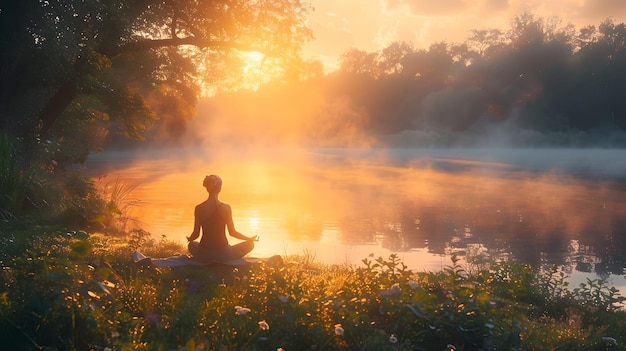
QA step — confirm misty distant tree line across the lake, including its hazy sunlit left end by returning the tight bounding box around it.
[200,13,626,147]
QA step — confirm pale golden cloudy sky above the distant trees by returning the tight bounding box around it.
[303,0,626,66]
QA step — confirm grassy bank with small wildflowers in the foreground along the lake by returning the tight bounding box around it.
[0,228,626,350]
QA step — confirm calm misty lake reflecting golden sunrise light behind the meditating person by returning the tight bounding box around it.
[87,147,626,295]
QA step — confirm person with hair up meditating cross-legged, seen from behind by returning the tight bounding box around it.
[187,174,258,263]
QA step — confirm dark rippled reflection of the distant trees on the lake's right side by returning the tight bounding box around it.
[338,184,626,276]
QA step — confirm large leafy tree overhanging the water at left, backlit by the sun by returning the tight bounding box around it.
[0,0,311,161]
